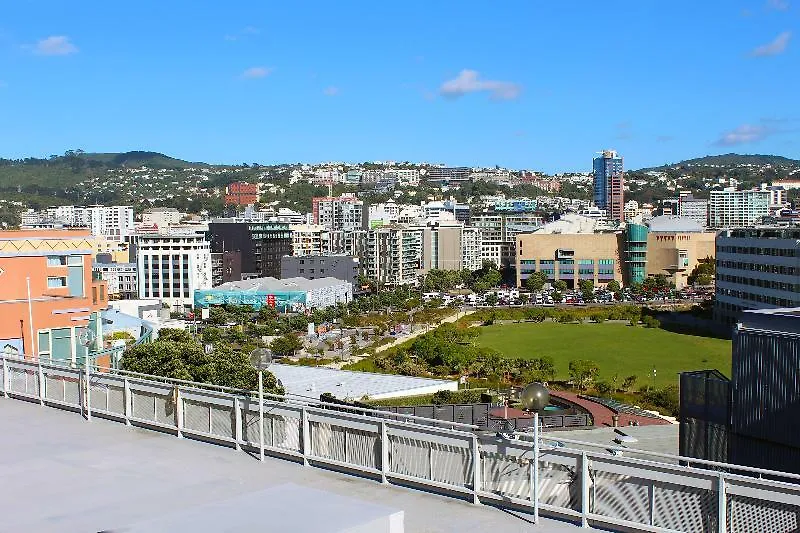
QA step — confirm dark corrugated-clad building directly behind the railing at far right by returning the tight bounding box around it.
[680,308,800,473]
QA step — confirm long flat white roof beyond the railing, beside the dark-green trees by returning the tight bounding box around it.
[268,363,458,400]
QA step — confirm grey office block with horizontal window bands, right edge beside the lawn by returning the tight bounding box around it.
[714,227,800,324]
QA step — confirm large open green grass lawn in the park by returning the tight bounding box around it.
[477,322,731,388]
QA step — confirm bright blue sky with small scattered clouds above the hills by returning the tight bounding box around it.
[0,0,800,172]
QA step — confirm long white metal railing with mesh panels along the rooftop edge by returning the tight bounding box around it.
[0,357,800,532]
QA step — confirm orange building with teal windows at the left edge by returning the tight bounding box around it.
[0,230,108,362]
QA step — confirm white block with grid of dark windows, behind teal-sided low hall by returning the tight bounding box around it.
[137,234,211,311]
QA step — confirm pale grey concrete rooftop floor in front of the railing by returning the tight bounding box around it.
[0,397,592,533]
